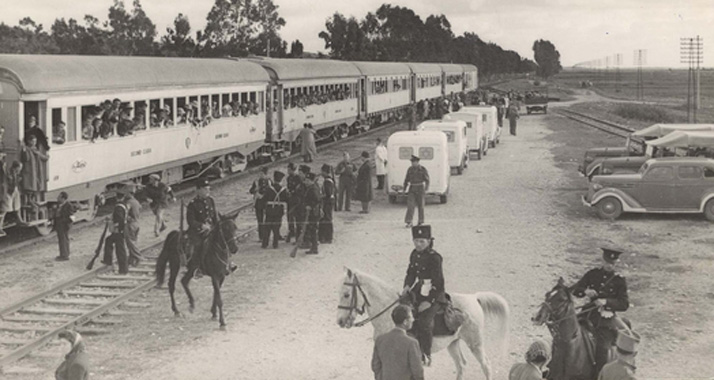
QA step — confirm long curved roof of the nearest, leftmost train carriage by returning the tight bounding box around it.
[0,54,270,94]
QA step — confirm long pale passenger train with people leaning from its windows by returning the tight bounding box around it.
[0,55,478,233]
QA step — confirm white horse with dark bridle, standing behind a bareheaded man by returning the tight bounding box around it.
[337,269,510,380]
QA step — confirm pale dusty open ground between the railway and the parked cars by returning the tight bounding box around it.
[2,91,714,380]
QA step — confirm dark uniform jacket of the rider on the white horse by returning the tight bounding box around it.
[404,248,446,304]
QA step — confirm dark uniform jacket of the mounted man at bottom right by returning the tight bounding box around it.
[572,268,630,311]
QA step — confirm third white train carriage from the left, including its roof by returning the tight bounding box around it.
[353,62,412,123]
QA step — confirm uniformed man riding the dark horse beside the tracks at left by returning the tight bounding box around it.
[186,179,219,278]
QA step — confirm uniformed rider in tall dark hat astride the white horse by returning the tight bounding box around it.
[394,225,448,366]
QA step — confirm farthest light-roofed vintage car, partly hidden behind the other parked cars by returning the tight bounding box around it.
[578,124,714,179]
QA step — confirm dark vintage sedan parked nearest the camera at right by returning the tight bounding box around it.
[582,157,714,221]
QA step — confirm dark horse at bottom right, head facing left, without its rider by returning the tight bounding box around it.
[532,277,597,380]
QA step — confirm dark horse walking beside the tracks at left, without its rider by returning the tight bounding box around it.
[155,217,238,329]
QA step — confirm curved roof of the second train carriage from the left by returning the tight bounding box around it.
[241,57,362,81]
